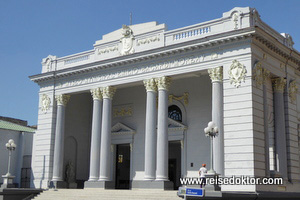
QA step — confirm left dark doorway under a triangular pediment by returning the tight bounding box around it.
[116,144,130,189]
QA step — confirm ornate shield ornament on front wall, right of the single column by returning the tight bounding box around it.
[228,60,247,88]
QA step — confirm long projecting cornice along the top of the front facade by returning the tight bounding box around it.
[29,27,255,83]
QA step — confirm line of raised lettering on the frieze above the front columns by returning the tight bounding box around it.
[56,55,204,88]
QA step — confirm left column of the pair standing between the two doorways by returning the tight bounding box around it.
[144,78,157,180]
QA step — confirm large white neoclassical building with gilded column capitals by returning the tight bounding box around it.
[30,7,300,197]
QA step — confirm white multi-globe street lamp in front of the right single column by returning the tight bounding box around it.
[204,121,219,174]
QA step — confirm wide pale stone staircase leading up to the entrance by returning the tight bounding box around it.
[34,188,181,200]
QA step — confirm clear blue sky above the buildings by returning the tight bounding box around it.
[0,0,300,125]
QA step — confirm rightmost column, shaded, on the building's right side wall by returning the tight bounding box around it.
[273,78,288,179]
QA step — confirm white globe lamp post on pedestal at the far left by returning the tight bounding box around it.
[1,139,17,188]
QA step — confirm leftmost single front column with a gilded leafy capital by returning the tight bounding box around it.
[52,94,70,182]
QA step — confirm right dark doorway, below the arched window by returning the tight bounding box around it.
[169,141,181,190]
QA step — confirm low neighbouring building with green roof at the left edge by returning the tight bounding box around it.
[0,116,36,188]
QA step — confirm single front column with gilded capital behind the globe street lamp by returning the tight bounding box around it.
[208,67,224,175]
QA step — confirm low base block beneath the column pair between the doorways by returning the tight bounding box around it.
[131,180,174,190]
